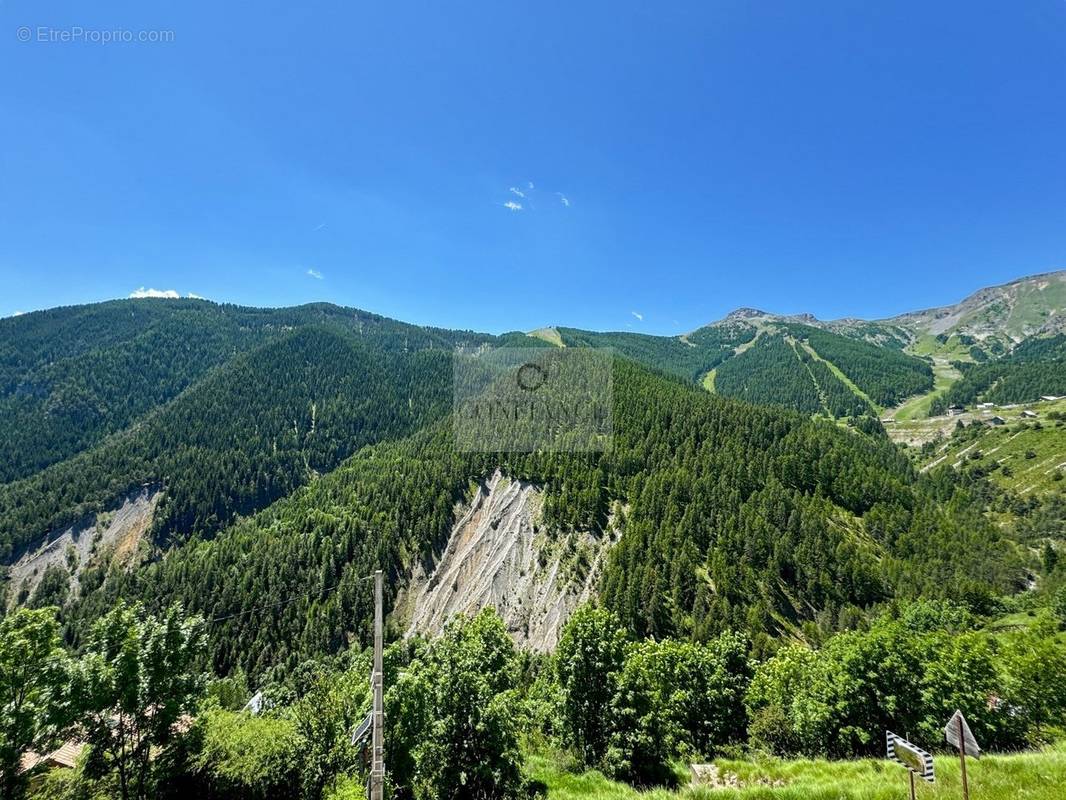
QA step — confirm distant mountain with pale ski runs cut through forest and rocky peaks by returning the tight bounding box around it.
[534,272,1066,418]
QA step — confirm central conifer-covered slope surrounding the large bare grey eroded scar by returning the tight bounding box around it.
[54,361,1023,674]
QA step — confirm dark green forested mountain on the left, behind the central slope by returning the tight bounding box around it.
[0,301,505,559]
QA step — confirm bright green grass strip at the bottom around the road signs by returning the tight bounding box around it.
[529,743,1066,800]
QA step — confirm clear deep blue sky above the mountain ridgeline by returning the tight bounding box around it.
[0,0,1066,333]
